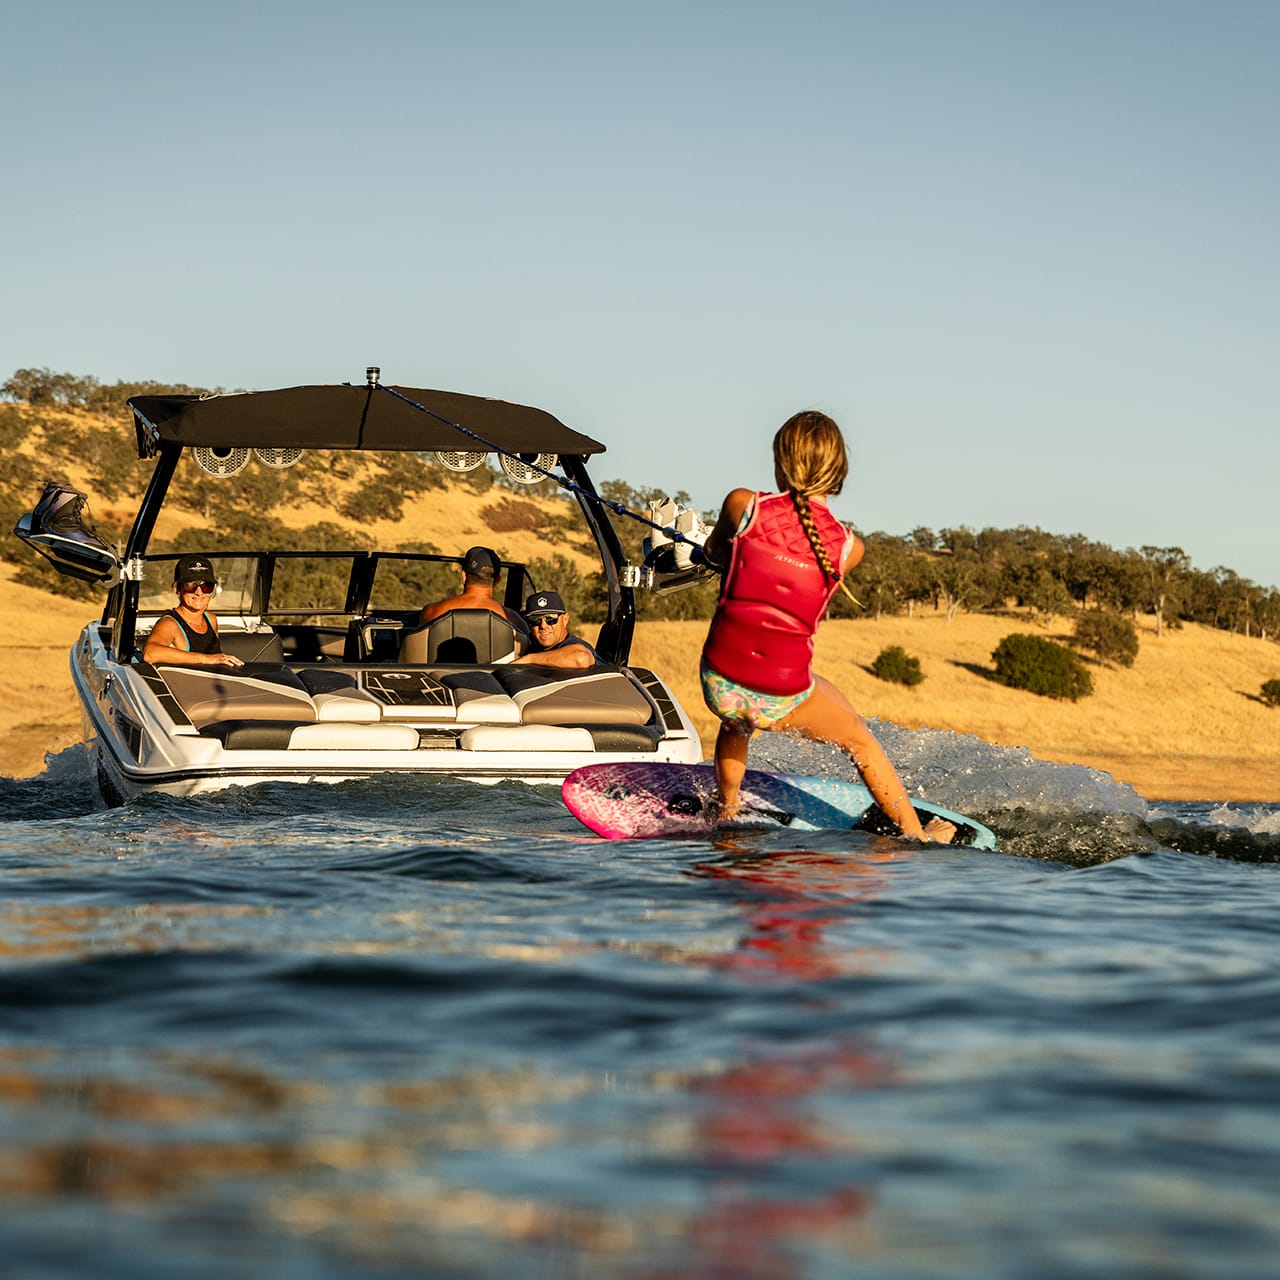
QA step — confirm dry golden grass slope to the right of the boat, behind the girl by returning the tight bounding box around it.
[632,612,1280,801]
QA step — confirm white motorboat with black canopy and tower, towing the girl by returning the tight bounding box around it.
[15,369,703,804]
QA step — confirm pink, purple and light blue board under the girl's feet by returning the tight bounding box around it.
[561,762,996,849]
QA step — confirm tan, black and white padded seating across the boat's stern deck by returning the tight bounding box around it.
[143,664,662,751]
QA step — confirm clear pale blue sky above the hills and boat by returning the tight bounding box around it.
[0,0,1280,586]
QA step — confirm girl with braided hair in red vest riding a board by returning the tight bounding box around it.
[701,410,955,844]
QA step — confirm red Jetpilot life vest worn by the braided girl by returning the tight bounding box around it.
[703,493,852,694]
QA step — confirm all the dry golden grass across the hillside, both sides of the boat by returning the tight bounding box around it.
[0,404,1280,801]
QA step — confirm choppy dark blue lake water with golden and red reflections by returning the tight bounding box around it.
[0,726,1280,1280]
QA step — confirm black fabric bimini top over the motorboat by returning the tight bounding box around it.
[129,384,604,454]
